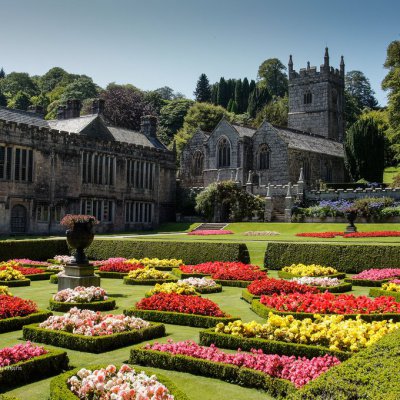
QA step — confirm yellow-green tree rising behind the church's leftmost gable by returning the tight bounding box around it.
[175,103,231,153]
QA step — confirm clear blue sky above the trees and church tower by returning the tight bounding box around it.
[0,0,400,105]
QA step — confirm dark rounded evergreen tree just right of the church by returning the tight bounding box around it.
[344,118,385,182]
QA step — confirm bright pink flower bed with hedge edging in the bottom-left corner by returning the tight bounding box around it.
[0,342,68,389]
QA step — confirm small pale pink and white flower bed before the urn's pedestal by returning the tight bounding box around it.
[50,286,115,312]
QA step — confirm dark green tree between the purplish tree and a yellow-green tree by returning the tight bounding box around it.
[157,99,194,145]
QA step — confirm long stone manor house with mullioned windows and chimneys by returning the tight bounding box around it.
[0,100,176,234]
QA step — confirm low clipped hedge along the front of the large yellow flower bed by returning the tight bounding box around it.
[199,328,352,360]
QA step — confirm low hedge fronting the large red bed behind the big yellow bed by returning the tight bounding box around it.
[251,299,400,322]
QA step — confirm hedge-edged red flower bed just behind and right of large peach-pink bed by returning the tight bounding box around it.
[124,293,236,328]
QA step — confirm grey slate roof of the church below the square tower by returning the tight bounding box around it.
[275,127,344,158]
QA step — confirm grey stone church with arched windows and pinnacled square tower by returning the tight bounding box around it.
[179,48,346,195]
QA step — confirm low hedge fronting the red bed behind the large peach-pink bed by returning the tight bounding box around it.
[124,307,239,328]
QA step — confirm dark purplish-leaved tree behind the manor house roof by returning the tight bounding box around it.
[100,83,154,131]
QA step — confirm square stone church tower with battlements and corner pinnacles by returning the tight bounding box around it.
[288,48,344,142]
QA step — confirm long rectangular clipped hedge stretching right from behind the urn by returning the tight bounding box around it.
[86,238,250,265]
